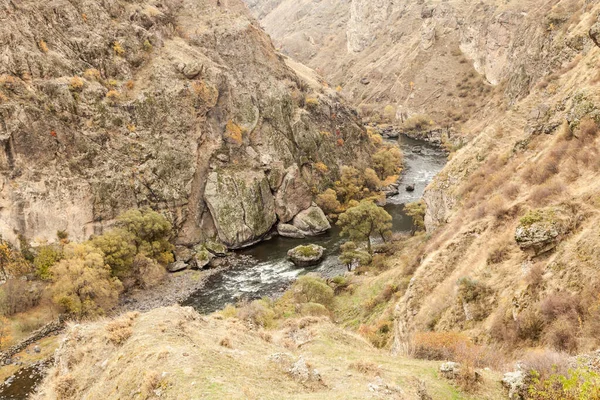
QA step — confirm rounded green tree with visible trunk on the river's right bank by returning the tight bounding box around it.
[337,200,392,255]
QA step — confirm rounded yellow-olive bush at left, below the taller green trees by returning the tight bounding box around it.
[50,244,122,318]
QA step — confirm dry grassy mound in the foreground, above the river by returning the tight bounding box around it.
[31,307,502,399]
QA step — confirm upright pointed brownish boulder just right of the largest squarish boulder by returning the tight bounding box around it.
[275,164,312,223]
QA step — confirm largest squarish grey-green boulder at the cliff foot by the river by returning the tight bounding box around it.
[204,168,277,249]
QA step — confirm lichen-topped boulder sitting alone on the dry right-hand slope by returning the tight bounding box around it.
[515,207,572,256]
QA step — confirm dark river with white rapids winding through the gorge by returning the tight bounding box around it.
[183,137,446,313]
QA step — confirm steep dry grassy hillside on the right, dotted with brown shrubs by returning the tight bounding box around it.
[396,2,600,353]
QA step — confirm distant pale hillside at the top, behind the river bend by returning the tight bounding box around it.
[247,0,589,126]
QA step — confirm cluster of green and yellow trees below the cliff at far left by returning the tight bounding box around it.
[0,208,173,319]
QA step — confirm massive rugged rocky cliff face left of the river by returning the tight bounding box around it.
[0,0,370,247]
